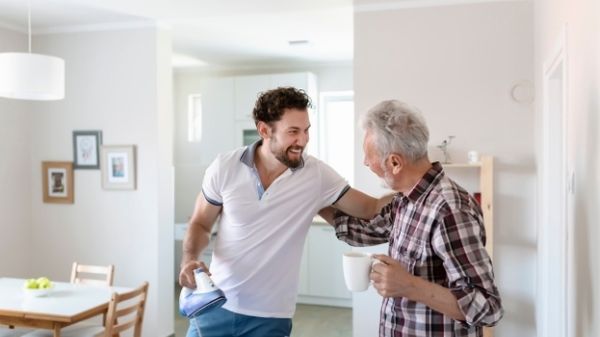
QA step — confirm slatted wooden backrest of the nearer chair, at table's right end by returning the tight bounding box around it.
[104,282,148,337]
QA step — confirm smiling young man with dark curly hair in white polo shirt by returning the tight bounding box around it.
[179,88,390,337]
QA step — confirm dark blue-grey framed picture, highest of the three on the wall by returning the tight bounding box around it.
[73,130,102,169]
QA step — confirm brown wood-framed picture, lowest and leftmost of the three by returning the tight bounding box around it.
[42,161,74,204]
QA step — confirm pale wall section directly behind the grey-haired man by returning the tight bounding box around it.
[354,1,536,337]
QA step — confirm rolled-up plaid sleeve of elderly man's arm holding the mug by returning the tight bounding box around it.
[433,211,504,326]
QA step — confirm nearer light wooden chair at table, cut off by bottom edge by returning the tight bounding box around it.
[24,282,148,337]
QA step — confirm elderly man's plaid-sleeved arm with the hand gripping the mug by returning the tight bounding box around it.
[370,211,504,326]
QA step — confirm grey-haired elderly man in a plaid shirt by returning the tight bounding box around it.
[321,101,503,337]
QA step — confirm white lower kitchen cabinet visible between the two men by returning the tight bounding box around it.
[298,223,352,307]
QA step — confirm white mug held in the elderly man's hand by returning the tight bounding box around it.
[342,252,375,291]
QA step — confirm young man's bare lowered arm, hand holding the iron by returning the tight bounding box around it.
[179,193,222,289]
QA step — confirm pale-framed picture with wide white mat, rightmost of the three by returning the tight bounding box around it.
[100,145,136,190]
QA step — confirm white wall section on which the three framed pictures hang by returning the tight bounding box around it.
[28,27,174,337]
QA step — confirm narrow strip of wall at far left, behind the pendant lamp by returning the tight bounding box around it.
[0,29,32,277]
